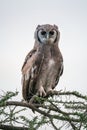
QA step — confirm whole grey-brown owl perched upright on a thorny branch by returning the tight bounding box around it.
[22,24,63,102]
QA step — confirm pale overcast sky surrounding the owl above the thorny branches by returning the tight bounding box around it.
[0,0,87,129]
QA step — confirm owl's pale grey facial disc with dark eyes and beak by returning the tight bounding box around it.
[38,30,57,44]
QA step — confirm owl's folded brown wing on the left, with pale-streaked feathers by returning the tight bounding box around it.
[22,49,43,101]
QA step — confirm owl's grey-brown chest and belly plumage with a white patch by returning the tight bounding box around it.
[39,45,60,87]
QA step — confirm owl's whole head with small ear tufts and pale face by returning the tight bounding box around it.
[35,24,60,45]
